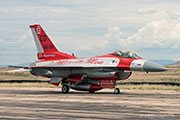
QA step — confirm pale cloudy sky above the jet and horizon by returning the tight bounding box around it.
[0,0,180,65]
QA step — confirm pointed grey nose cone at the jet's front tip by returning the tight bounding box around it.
[143,61,167,72]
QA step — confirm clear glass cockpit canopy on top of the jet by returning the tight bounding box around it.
[111,50,141,58]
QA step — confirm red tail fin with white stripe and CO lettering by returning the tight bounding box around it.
[29,25,74,59]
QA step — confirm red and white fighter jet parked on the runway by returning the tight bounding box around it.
[10,25,167,94]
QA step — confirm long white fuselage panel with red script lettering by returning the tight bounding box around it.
[36,57,120,67]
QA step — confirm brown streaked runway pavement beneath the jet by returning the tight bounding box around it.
[0,87,180,120]
